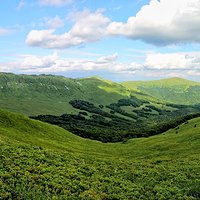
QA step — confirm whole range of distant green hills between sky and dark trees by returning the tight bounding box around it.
[0,73,200,116]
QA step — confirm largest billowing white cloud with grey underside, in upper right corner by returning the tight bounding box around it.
[107,0,200,45]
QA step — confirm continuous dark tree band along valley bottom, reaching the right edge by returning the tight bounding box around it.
[32,113,200,142]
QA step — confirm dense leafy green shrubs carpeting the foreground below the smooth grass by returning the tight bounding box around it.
[0,145,200,200]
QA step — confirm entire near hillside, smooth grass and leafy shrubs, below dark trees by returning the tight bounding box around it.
[0,110,200,200]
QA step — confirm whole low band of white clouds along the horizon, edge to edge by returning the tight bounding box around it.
[0,52,200,78]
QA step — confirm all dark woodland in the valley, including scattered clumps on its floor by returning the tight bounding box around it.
[32,97,200,142]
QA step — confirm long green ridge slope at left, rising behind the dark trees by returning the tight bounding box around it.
[0,73,130,115]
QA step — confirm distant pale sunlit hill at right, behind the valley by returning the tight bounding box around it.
[122,78,200,104]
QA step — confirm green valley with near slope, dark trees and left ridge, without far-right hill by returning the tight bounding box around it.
[0,73,200,200]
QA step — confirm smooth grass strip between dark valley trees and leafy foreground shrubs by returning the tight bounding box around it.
[0,110,200,158]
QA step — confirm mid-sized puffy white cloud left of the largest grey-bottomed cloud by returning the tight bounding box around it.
[26,11,110,49]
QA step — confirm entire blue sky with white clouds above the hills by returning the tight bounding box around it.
[0,0,200,81]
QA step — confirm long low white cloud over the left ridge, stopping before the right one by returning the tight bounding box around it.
[0,53,141,73]
